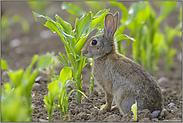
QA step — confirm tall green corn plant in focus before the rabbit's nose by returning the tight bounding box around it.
[33,9,109,103]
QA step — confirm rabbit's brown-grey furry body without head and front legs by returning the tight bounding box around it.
[93,53,162,114]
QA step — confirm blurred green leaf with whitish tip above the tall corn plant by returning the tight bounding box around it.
[61,2,85,16]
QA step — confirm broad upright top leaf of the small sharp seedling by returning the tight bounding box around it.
[59,67,72,84]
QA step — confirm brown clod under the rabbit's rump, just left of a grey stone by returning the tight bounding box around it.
[137,109,152,119]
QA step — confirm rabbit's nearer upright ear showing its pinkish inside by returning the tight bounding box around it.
[104,14,114,37]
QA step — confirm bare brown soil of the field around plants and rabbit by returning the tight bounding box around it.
[1,1,182,122]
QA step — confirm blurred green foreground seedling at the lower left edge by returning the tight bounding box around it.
[1,55,51,122]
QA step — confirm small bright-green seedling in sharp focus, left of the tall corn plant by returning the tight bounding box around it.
[44,67,74,121]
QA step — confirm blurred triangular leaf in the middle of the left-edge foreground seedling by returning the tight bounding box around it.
[8,69,24,88]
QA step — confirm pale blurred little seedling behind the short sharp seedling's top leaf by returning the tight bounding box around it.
[40,52,59,82]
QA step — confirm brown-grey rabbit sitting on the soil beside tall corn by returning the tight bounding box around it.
[81,12,163,118]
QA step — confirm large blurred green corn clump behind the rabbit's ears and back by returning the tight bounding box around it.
[110,1,177,74]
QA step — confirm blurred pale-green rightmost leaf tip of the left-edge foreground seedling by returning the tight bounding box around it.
[37,54,52,69]
